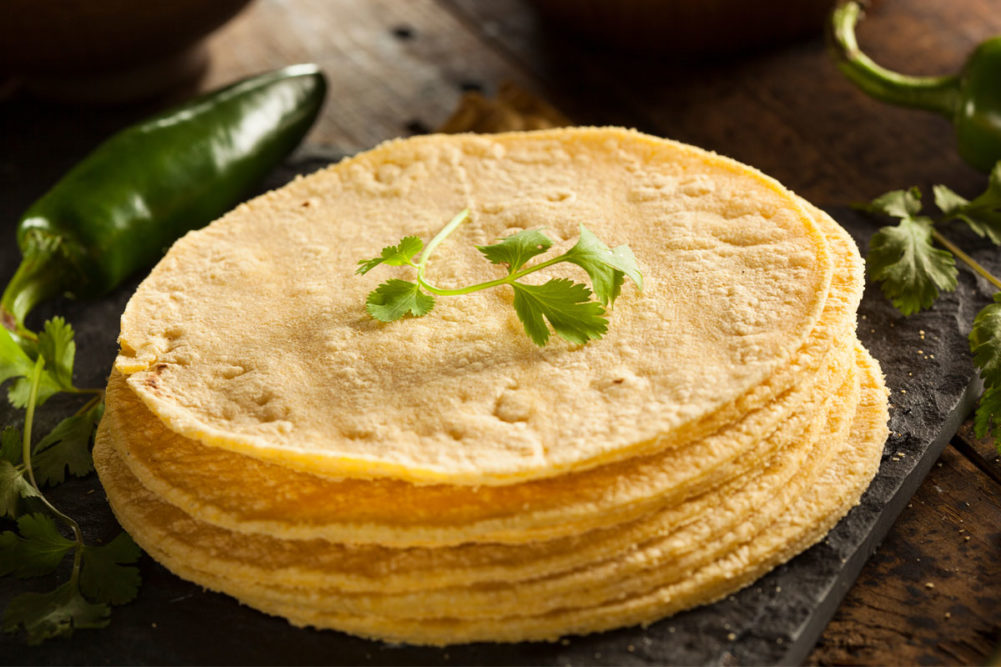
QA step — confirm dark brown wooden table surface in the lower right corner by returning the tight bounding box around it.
[808,440,1001,665]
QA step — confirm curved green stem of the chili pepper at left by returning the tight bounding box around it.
[0,234,73,341]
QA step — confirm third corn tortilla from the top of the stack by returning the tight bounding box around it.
[97,348,844,593]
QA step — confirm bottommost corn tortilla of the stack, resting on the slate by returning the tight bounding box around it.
[95,344,887,644]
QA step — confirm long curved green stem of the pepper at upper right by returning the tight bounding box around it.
[831,2,959,119]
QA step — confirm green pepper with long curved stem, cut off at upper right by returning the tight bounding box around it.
[831,2,1001,171]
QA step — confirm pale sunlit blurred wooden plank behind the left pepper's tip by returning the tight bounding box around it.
[201,0,538,152]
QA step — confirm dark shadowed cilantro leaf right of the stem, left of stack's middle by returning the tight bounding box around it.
[31,403,104,485]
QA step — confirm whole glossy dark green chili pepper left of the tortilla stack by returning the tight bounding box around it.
[0,65,326,338]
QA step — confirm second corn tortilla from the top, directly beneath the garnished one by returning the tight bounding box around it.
[99,198,863,547]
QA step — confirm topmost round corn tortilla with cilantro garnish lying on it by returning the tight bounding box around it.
[116,128,832,485]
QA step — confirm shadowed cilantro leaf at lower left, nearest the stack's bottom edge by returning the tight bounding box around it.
[80,533,142,605]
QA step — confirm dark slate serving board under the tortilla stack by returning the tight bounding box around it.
[0,149,988,665]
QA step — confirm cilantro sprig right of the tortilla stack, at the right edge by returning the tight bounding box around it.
[864,162,1001,440]
